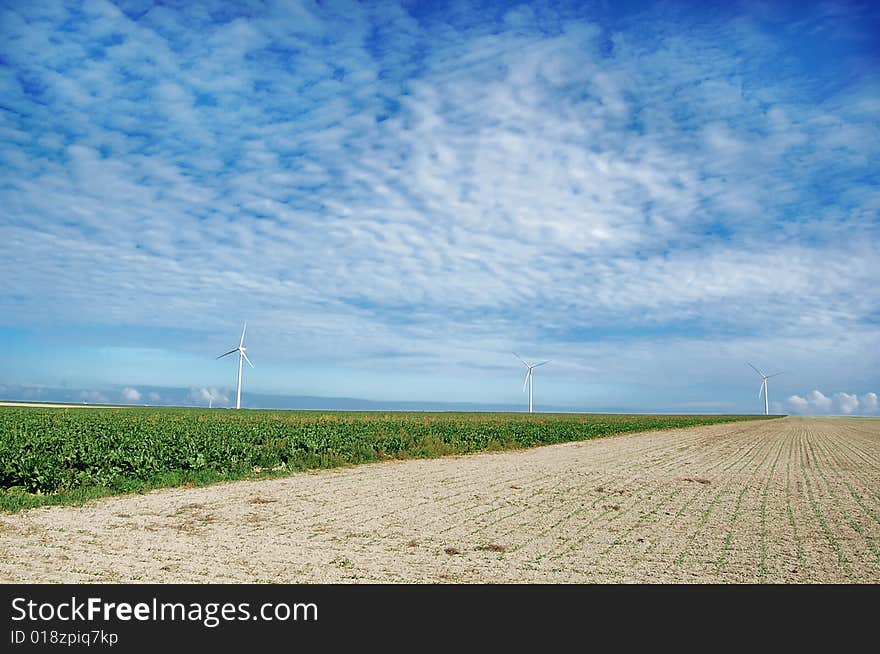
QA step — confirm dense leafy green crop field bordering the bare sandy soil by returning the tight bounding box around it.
[0,407,764,510]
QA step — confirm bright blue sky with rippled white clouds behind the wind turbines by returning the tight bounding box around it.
[0,0,880,414]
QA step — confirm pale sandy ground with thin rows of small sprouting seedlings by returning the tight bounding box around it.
[0,418,880,583]
